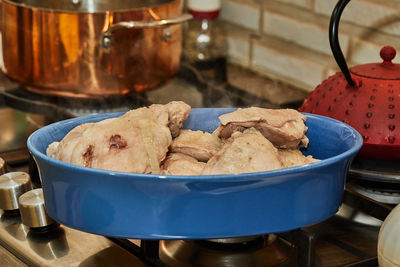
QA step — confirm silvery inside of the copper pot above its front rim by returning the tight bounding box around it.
[3,0,173,13]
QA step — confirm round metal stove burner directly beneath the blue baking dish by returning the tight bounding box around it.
[159,235,295,267]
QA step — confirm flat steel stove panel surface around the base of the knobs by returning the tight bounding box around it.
[0,211,145,267]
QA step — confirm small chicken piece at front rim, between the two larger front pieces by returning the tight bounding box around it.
[161,153,206,175]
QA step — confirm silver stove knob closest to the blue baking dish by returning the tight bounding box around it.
[19,188,55,228]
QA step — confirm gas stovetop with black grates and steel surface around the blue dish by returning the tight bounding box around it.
[0,64,394,266]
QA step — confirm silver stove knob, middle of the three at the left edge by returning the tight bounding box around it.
[0,172,32,210]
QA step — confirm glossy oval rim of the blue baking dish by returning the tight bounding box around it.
[27,108,363,181]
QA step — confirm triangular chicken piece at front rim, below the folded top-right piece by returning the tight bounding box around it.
[202,128,283,175]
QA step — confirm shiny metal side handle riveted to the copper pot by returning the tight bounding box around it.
[101,13,193,49]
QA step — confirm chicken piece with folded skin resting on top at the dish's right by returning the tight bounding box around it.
[216,107,308,148]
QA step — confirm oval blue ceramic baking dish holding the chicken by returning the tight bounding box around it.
[28,108,362,239]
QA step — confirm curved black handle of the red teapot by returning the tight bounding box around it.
[329,0,355,86]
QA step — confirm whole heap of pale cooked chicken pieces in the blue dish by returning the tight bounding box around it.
[47,101,318,175]
